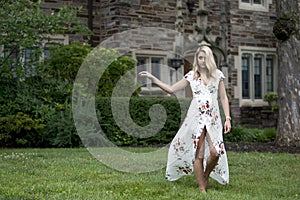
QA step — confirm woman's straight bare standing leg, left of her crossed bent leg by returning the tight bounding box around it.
[194,130,206,193]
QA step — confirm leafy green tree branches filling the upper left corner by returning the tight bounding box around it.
[0,0,91,78]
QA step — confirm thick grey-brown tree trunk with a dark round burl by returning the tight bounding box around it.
[273,0,300,147]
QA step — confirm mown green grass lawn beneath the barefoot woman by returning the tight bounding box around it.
[0,149,300,200]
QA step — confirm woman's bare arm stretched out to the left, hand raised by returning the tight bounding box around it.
[139,71,189,94]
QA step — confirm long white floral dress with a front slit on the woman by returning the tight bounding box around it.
[166,70,229,184]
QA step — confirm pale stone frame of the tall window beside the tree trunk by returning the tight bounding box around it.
[235,47,278,107]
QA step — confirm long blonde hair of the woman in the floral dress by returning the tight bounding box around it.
[193,45,217,79]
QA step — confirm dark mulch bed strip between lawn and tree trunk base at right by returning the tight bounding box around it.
[225,142,300,154]
